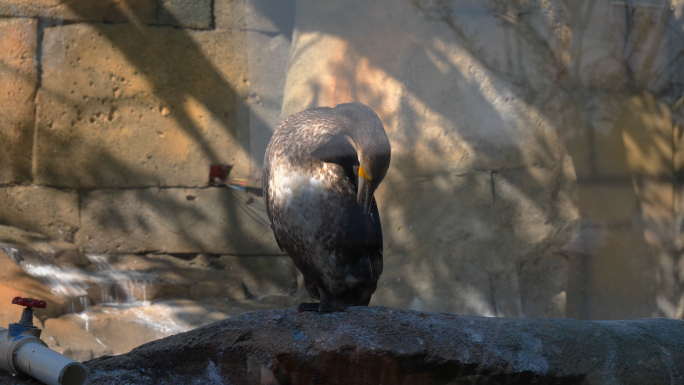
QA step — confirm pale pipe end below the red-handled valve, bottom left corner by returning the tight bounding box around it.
[0,324,90,385]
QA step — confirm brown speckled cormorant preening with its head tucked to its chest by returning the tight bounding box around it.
[262,103,391,313]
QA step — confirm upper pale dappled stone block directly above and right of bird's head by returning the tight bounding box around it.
[283,0,572,172]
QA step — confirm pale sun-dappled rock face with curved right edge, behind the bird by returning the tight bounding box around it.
[283,1,577,316]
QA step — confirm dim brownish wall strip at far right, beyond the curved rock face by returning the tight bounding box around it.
[566,1,684,319]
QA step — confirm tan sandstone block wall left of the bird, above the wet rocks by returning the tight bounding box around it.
[0,0,280,254]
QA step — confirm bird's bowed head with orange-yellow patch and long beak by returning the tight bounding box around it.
[335,103,391,215]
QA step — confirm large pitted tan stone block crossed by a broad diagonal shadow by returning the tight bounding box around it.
[36,24,249,188]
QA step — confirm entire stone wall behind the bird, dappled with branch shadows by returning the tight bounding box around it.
[0,0,684,324]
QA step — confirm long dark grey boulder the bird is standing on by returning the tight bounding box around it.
[5,307,684,385]
